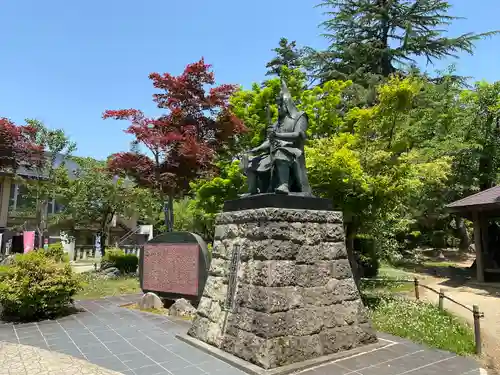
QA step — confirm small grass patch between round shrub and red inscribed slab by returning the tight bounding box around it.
[75,272,141,299]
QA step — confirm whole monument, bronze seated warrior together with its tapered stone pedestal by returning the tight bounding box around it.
[180,83,377,374]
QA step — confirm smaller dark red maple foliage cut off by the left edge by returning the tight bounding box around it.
[0,117,43,173]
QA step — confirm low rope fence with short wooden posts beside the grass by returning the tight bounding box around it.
[362,277,484,355]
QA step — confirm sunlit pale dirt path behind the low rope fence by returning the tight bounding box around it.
[420,277,500,374]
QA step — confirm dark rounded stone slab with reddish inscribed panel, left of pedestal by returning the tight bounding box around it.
[139,232,210,300]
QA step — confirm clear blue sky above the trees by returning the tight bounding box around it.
[0,0,500,158]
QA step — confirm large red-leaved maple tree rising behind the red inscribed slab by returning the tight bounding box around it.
[103,58,245,223]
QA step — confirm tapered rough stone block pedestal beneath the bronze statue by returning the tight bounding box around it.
[188,208,377,369]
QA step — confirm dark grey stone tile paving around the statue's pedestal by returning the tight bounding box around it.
[0,296,482,375]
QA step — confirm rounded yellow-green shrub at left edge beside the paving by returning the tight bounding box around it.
[0,251,80,320]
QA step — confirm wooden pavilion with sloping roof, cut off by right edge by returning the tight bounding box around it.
[446,185,500,282]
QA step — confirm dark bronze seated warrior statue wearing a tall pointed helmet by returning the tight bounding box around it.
[241,81,311,196]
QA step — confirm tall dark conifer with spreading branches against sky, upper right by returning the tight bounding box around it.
[312,0,497,85]
